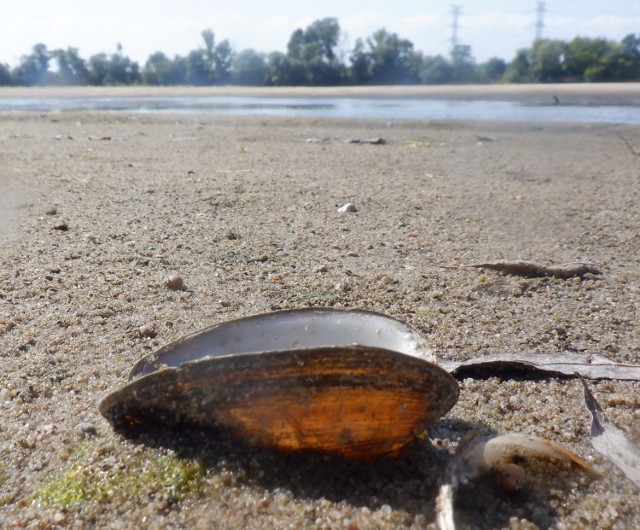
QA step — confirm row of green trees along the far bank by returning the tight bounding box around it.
[0,18,640,86]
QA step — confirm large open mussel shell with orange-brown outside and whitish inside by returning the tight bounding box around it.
[100,309,459,458]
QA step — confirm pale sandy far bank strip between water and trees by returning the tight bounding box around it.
[0,83,640,105]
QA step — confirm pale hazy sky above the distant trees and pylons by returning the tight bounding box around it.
[0,0,640,66]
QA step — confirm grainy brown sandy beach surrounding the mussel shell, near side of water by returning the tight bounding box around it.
[0,89,640,530]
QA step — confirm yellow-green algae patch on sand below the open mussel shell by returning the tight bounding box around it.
[33,446,207,509]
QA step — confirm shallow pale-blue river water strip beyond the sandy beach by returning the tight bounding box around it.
[0,96,640,125]
